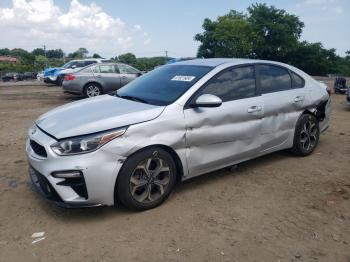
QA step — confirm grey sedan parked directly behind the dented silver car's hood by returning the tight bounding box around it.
[62,63,142,97]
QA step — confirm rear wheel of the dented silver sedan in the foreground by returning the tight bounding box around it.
[292,114,320,156]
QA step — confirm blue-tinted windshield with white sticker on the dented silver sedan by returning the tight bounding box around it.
[114,65,212,106]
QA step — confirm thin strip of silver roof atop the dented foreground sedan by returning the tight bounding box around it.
[170,58,287,67]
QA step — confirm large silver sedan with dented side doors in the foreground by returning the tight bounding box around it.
[26,59,331,210]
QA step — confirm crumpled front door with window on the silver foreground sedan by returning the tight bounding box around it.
[184,65,264,175]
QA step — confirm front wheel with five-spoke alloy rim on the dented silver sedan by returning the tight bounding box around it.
[115,147,176,211]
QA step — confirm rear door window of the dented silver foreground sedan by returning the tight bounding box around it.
[259,65,292,94]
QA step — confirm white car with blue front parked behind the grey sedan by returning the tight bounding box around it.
[44,58,110,85]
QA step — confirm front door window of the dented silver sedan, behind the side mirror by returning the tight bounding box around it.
[199,66,255,102]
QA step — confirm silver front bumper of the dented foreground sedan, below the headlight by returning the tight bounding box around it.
[26,126,124,208]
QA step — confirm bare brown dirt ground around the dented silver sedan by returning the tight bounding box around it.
[0,82,350,262]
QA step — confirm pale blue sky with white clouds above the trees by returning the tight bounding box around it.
[0,0,350,58]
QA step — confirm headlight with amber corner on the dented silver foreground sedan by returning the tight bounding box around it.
[51,127,127,156]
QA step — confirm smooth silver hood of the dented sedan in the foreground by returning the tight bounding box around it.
[36,95,165,139]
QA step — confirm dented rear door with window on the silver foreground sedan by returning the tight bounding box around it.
[257,64,306,152]
